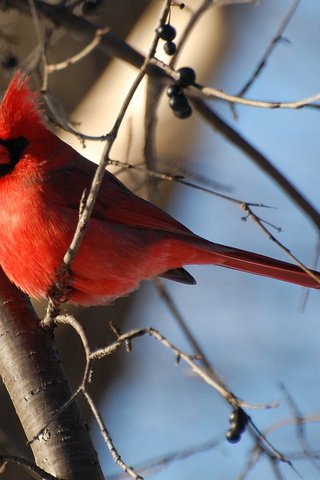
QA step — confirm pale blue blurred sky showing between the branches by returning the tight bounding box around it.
[98,0,320,480]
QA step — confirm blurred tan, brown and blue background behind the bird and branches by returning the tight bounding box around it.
[0,0,320,480]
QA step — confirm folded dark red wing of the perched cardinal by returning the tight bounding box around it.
[49,150,193,235]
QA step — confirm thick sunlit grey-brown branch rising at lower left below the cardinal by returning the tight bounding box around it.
[0,270,103,480]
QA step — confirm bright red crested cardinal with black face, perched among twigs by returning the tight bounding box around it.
[0,73,320,305]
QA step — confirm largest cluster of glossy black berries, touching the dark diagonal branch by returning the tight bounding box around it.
[167,67,196,118]
